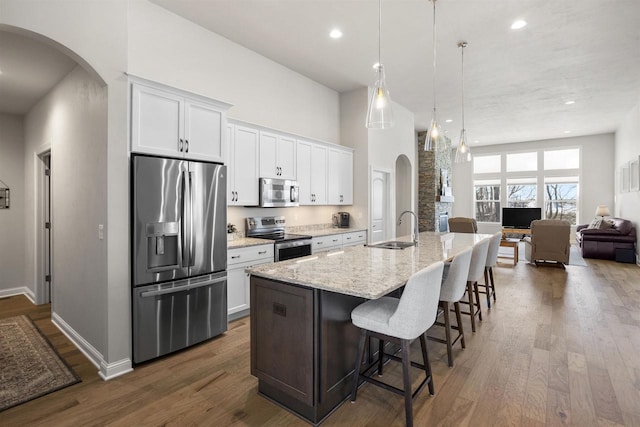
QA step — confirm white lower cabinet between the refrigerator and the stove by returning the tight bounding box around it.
[227,243,273,321]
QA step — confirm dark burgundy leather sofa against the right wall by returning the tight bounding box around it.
[576,217,636,259]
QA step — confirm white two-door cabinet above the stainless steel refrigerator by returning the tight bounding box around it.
[131,82,229,163]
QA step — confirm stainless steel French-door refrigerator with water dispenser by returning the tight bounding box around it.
[131,154,227,363]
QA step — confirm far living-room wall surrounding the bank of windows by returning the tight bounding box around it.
[452,134,614,232]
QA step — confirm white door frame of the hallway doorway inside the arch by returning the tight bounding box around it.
[33,143,53,304]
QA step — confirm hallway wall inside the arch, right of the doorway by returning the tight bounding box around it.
[25,67,107,364]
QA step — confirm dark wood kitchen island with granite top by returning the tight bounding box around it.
[249,232,489,424]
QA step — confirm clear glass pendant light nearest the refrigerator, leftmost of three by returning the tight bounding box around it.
[366,0,393,129]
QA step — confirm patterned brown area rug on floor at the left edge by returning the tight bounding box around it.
[0,316,80,411]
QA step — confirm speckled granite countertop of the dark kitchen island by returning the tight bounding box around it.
[247,232,491,299]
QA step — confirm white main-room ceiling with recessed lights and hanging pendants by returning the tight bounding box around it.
[152,0,640,144]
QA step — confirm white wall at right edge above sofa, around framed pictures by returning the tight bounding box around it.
[612,95,640,260]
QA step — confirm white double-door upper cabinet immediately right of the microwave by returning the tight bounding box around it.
[296,140,327,205]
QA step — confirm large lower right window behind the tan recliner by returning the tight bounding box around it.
[544,176,578,225]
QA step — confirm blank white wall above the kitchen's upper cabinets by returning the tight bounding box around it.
[129,1,340,143]
